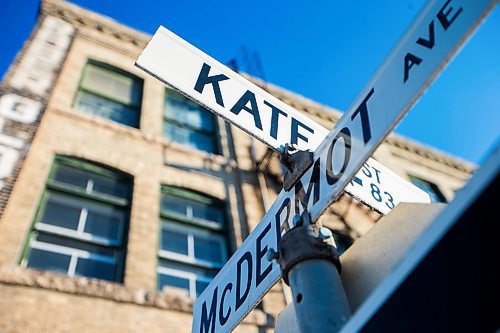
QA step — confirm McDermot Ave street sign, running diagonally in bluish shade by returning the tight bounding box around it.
[137,0,495,333]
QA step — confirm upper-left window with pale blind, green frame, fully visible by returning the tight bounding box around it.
[75,61,142,128]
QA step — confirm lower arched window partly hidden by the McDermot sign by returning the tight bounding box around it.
[158,186,227,298]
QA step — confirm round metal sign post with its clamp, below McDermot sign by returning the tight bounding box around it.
[275,211,351,333]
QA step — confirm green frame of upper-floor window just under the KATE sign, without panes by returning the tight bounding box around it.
[162,88,222,155]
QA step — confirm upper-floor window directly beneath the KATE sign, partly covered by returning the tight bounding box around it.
[163,90,218,154]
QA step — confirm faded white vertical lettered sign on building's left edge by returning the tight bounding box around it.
[0,16,75,217]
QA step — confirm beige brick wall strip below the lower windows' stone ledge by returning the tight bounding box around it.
[0,284,191,333]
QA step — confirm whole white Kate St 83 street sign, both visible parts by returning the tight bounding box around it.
[136,27,431,214]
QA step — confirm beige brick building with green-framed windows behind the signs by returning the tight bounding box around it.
[0,0,473,333]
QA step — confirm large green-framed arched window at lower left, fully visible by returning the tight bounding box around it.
[21,157,132,282]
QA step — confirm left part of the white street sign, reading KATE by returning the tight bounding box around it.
[136,27,328,151]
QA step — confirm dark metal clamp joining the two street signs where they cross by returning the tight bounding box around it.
[280,143,313,191]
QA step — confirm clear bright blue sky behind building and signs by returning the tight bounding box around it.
[0,0,500,164]
